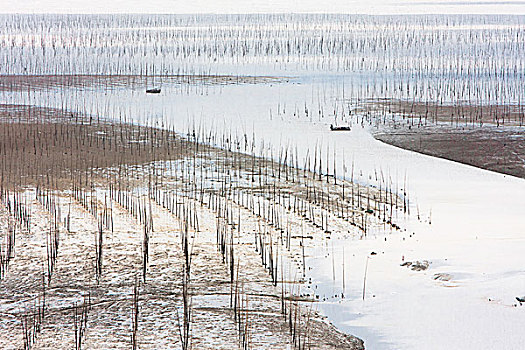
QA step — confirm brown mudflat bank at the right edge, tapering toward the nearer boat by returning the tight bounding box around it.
[373,102,525,178]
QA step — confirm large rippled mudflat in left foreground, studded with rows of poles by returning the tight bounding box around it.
[0,106,370,349]
